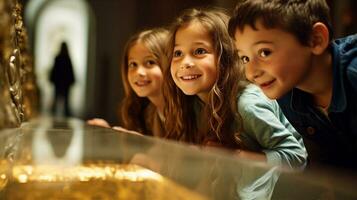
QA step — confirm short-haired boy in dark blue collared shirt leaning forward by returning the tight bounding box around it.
[229,0,357,168]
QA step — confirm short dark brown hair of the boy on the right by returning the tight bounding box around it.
[228,0,333,45]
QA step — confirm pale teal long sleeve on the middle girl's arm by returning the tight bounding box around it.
[238,85,307,168]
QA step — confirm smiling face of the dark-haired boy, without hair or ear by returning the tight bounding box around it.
[234,22,311,99]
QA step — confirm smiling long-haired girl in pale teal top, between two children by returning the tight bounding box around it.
[164,9,307,170]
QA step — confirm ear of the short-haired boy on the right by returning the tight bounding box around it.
[310,22,330,55]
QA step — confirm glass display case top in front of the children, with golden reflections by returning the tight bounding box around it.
[0,118,357,200]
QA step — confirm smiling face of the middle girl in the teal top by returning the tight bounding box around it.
[170,22,217,102]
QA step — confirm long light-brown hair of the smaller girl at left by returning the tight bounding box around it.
[119,28,168,135]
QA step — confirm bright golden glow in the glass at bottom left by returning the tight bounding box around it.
[0,164,205,200]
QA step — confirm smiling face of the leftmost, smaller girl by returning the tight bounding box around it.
[127,43,163,98]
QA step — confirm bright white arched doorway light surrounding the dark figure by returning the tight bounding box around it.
[34,0,89,117]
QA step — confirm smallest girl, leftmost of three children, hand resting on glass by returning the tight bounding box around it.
[88,28,168,136]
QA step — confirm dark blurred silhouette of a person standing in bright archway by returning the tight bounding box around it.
[50,42,75,116]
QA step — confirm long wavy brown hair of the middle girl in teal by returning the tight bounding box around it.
[164,8,247,147]
